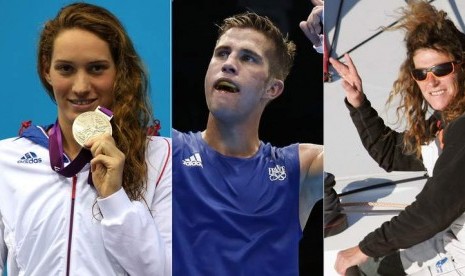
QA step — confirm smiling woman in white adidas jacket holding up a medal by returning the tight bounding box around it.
[0,3,171,275]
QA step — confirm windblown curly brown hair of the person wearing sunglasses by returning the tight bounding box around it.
[388,0,465,157]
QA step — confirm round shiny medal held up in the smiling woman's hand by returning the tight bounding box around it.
[72,111,112,147]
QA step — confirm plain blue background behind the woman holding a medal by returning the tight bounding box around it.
[0,0,171,139]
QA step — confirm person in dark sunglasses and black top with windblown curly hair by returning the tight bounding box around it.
[330,1,465,275]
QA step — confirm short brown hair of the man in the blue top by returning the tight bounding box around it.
[218,12,296,81]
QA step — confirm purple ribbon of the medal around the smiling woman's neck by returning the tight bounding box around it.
[48,106,113,185]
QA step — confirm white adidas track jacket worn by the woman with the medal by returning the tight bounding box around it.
[0,126,171,276]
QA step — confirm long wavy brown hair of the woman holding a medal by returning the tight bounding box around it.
[37,3,153,200]
